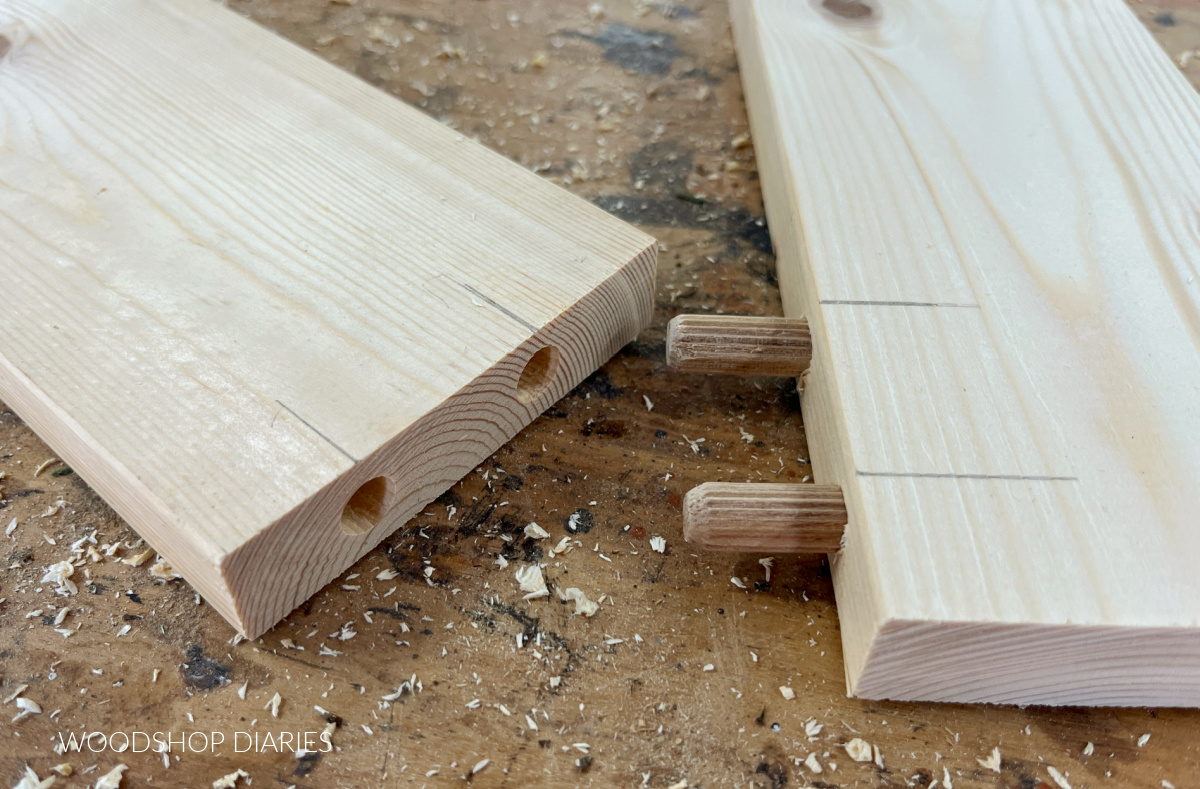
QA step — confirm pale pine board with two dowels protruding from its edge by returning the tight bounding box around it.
[733,0,1200,706]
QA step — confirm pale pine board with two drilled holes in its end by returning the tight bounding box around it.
[0,0,655,637]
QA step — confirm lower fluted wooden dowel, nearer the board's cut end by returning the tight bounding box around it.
[683,482,846,554]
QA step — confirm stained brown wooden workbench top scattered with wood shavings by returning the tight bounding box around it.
[0,0,1200,789]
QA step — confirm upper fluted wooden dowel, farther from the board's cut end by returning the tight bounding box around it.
[667,315,812,375]
